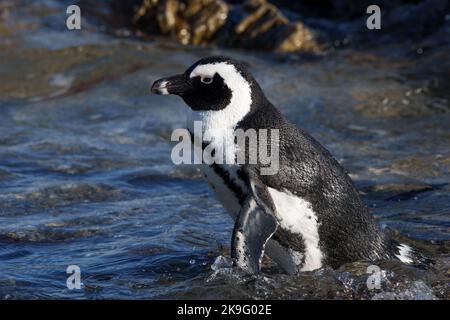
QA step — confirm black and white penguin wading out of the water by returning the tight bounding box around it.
[151,56,424,274]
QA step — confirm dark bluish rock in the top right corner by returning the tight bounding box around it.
[308,0,450,47]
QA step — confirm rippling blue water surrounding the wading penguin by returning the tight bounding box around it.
[0,1,450,299]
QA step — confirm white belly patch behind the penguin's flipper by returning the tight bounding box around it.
[268,188,323,271]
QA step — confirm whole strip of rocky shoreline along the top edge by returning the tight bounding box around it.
[112,0,450,54]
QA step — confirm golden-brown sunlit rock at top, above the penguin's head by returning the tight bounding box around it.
[134,0,321,52]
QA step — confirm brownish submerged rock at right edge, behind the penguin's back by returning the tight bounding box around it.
[351,53,450,118]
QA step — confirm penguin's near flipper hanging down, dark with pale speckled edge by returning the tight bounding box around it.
[231,166,278,274]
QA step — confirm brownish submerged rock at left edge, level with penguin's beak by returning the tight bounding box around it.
[0,40,153,99]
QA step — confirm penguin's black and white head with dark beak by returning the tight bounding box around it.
[151,57,260,116]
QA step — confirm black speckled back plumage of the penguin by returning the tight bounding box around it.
[237,75,393,267]
